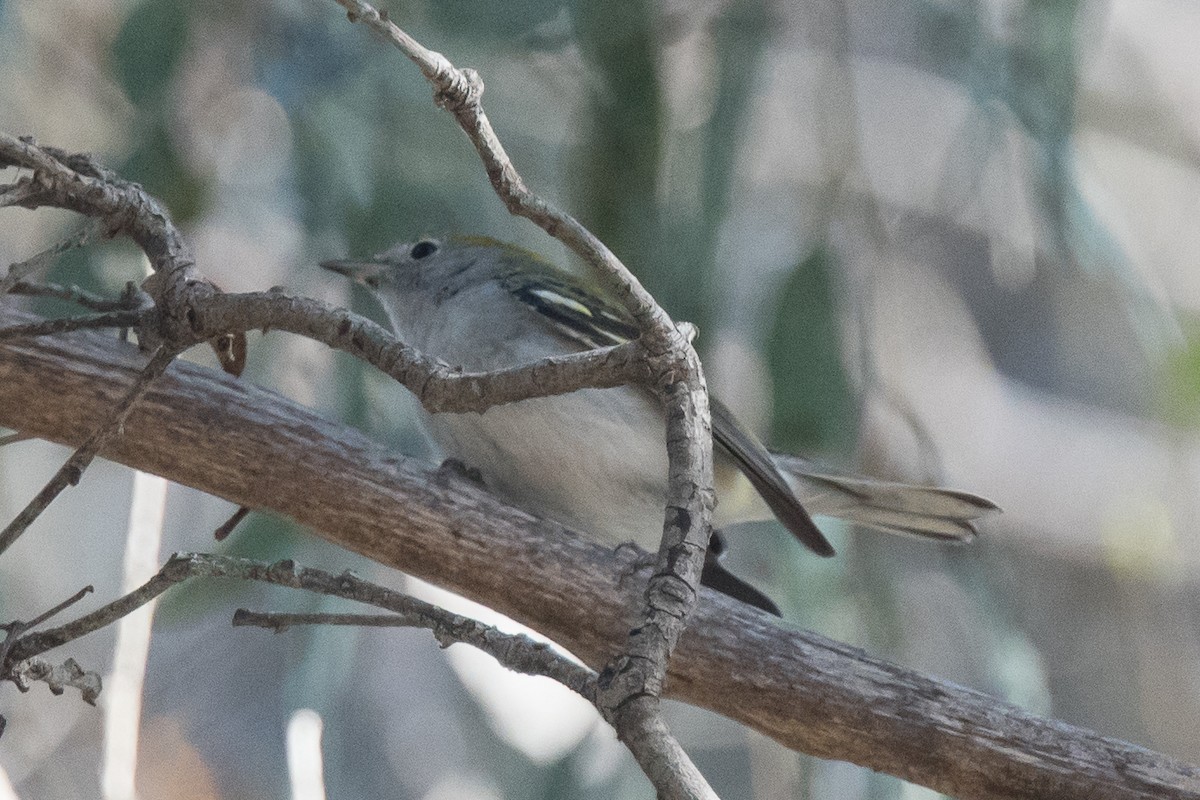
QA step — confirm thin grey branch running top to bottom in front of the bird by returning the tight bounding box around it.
[337,0,715,798]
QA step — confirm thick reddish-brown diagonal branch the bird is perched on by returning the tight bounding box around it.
[0,309,1200,800]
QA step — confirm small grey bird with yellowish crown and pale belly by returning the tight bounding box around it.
[320,235,997,615]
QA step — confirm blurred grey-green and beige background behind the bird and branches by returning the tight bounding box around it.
[0,0,1200,800]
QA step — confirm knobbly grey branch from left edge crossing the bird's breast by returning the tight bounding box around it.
[0,132,650,411]
